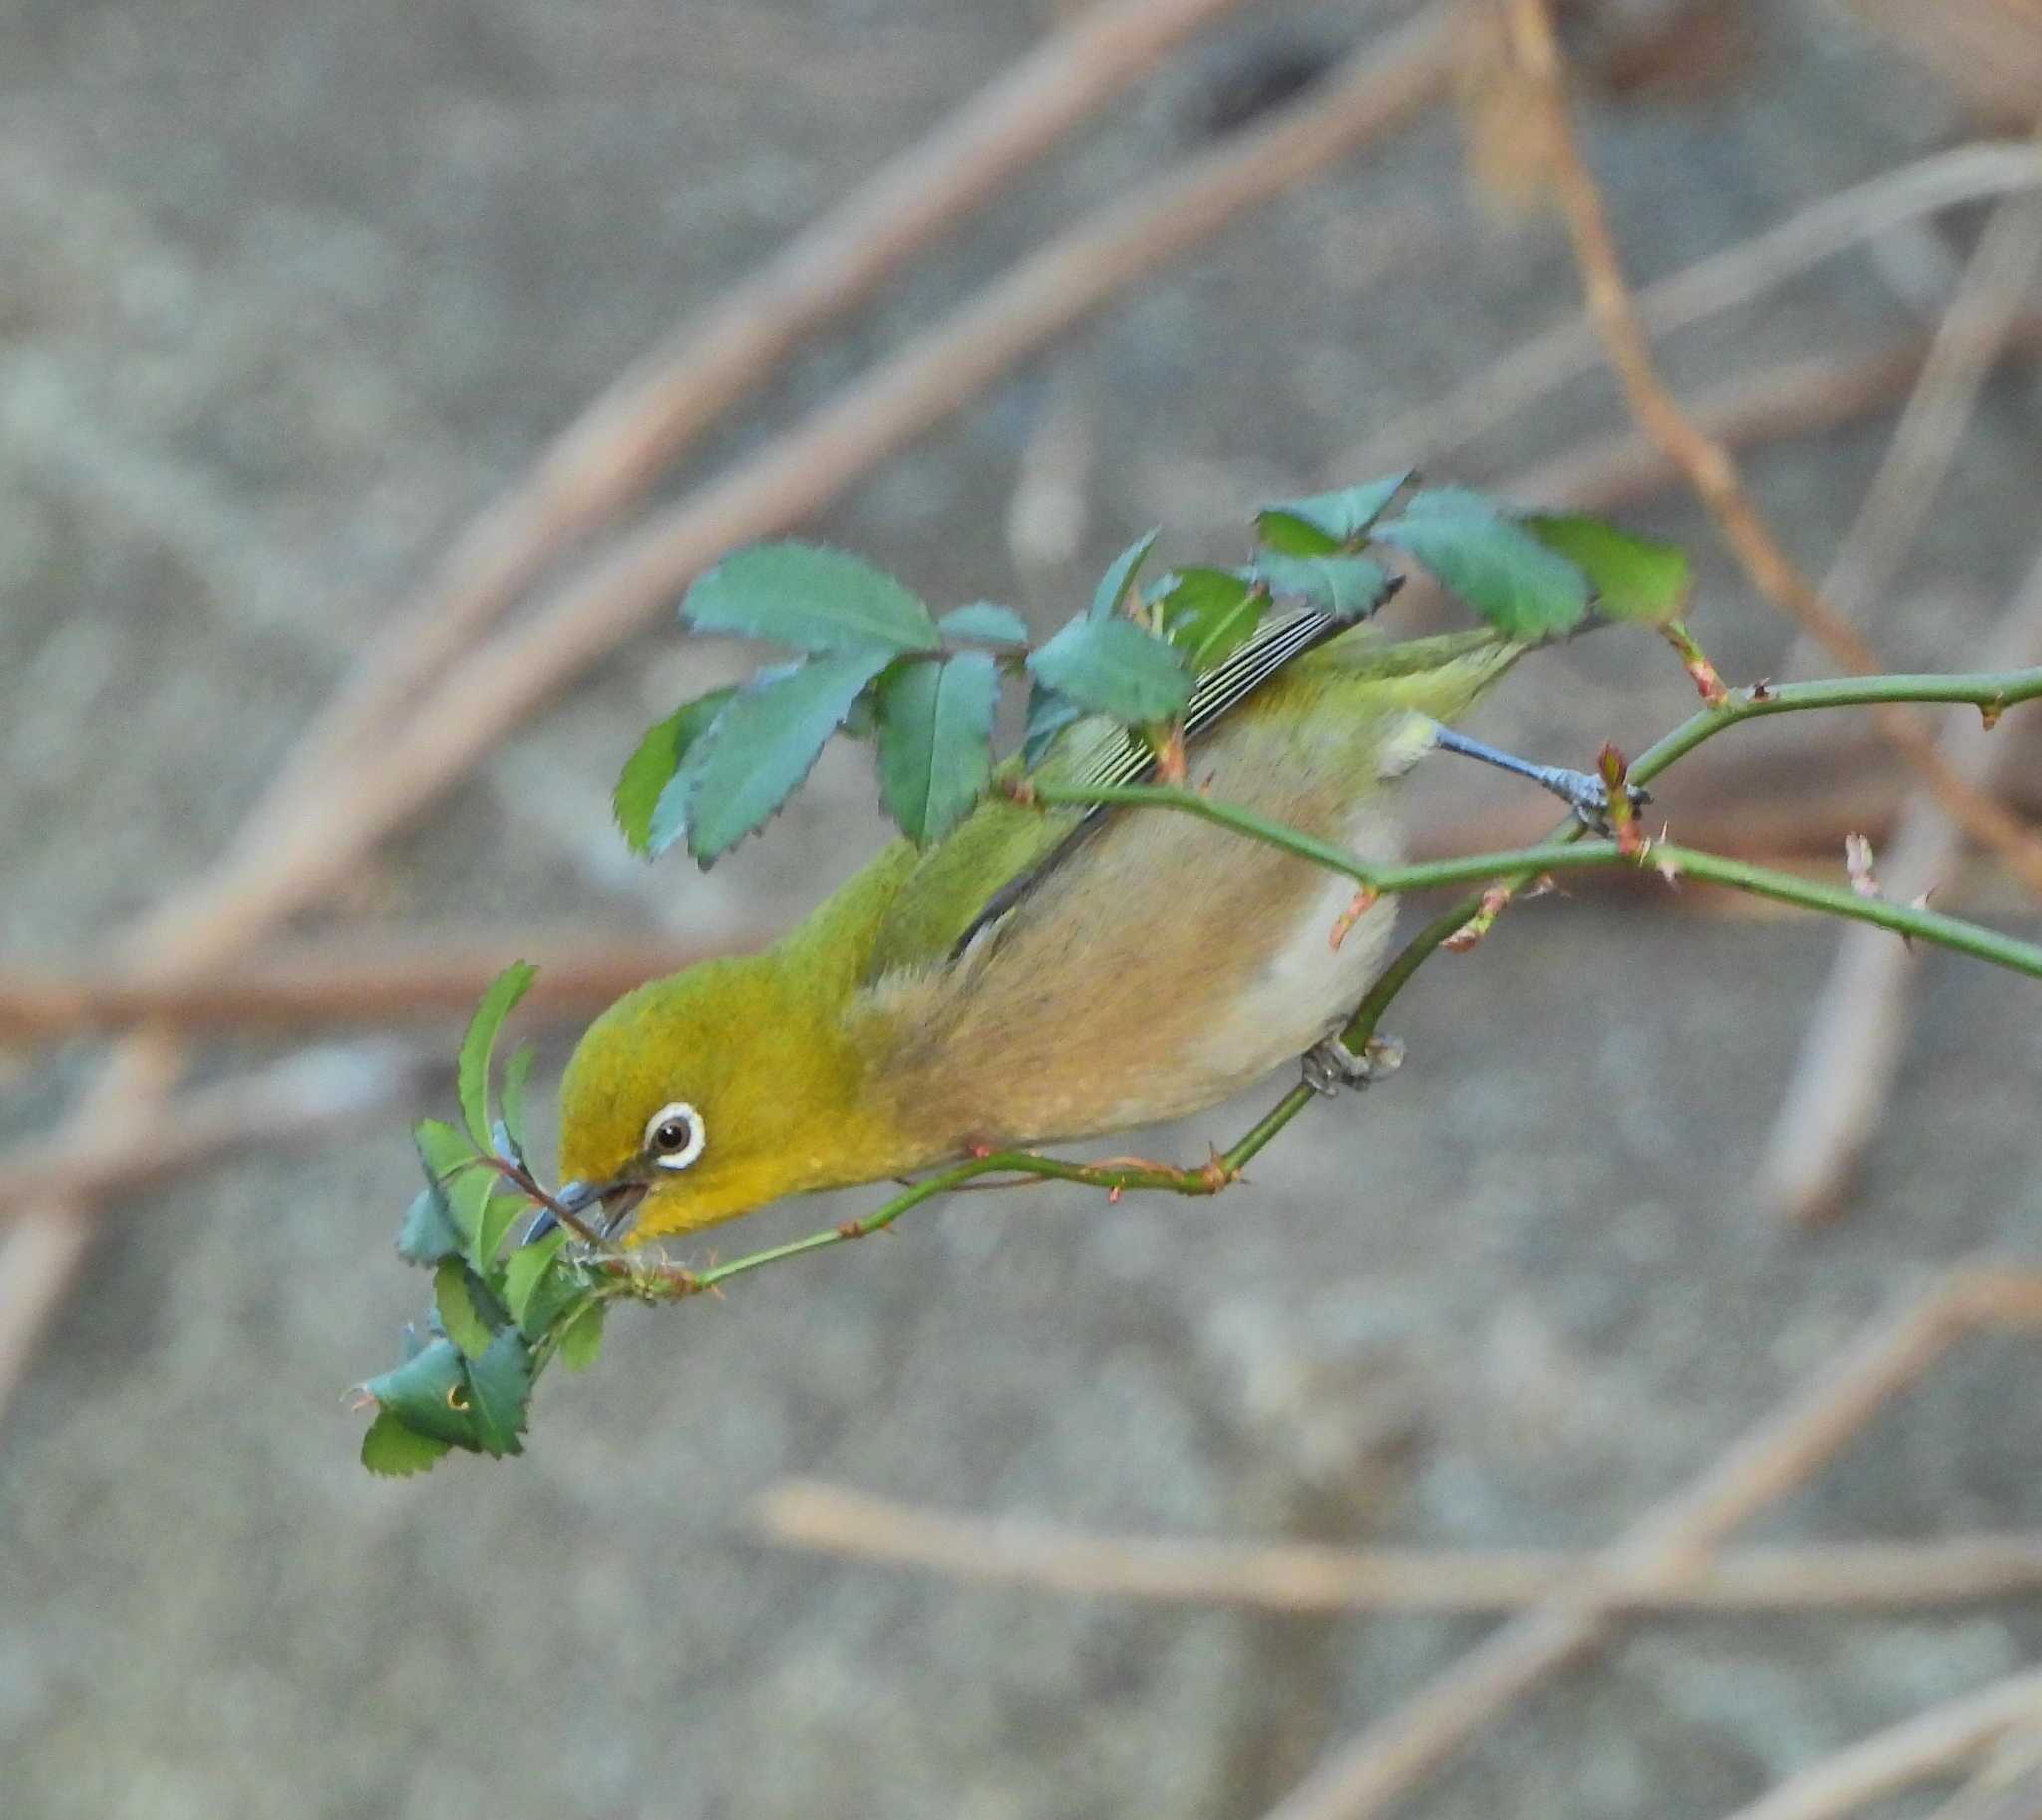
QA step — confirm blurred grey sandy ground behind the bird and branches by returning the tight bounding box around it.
[0,0,2042,1820]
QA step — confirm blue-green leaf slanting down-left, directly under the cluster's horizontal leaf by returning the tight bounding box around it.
[651,651,892,869]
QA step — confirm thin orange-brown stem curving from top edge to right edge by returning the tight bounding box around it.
[1507,0,2042,897]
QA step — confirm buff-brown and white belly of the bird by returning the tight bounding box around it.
[869,702,1426,1148]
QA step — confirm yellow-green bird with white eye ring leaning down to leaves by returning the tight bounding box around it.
[542,612,1605,1238]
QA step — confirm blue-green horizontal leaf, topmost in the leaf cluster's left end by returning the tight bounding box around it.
[680,542,939,655]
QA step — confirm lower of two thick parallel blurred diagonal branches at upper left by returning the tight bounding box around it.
[136,12,1454,967]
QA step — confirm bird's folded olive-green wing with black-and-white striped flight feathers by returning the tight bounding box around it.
[865,610,1388,980]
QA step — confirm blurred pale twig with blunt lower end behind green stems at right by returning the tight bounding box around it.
[1756,539,2042,1220]
